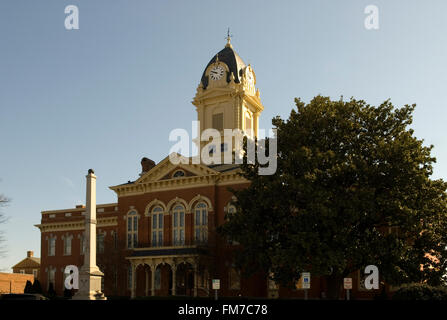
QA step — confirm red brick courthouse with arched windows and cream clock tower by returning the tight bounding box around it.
[37,39,376,298]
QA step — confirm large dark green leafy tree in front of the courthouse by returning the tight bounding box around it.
[219,96,447,298]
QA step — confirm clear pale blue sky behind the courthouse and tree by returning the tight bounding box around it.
[0,0,447,272]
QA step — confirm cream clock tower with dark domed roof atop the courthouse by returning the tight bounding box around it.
[192,35,264,159]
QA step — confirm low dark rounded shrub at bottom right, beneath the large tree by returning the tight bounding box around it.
[393,283,447,300]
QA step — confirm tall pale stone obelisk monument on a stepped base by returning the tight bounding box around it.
[73,169,107,300]
